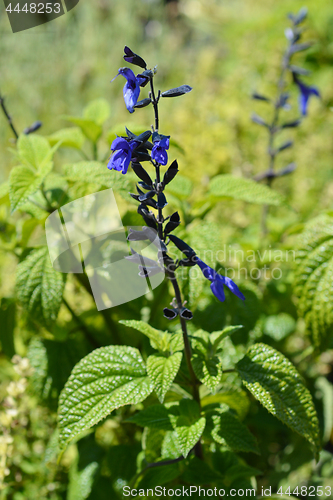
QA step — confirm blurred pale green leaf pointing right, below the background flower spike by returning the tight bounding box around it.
[209,174,285,205]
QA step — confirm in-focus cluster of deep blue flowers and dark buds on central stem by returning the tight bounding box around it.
[108,47,245,312]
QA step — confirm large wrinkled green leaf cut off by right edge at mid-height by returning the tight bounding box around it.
[294,215,333,350]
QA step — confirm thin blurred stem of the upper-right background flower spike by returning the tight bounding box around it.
[261,42,292,236]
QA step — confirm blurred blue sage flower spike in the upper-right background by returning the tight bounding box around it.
[252,7,320,234]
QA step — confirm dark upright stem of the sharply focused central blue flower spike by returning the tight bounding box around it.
[150,77,203,459]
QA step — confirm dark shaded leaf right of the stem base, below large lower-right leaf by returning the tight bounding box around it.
[212,409,259,454]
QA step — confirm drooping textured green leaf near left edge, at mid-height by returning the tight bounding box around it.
[16,247,67,326]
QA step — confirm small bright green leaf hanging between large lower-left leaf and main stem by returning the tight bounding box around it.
[147,352,183,403]
